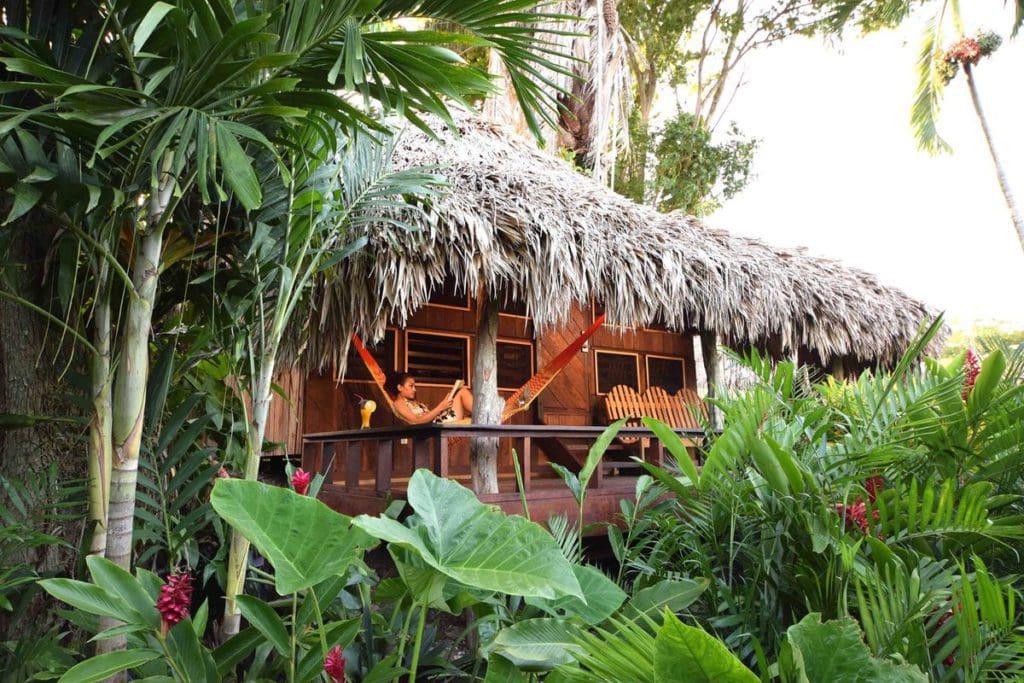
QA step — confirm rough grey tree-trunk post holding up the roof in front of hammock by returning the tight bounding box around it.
[470,288,503,495]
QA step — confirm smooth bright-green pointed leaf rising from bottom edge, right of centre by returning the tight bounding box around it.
[654,610,757,683]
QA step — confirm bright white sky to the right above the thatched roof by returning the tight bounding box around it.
[692,0,1024,325]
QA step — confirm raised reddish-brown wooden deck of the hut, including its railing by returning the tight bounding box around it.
[302,424,703,532]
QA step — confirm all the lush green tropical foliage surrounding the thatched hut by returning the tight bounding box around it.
[0,0,1024,683]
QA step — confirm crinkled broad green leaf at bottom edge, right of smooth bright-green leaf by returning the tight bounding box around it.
[786,612,928,683]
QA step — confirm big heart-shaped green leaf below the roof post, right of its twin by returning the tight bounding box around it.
[354,470,584,599]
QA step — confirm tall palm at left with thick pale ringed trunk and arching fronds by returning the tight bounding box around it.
[0,0,569,647]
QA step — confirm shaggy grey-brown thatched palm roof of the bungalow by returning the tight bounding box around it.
[306,118,932,374]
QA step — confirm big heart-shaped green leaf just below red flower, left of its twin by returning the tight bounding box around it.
[210,479,374,594]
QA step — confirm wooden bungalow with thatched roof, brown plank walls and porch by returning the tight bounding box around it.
[267,113,931,519]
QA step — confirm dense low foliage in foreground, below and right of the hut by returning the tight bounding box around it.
[29,328,1024,681]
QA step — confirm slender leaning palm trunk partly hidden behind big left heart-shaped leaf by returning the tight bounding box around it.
[220,345,278,642]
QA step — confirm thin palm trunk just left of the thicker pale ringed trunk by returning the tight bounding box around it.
[88,262,114,555]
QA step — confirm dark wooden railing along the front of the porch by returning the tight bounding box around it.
[302,424,705,495]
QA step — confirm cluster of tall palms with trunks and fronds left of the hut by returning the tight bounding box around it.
[0,0,573,648]
